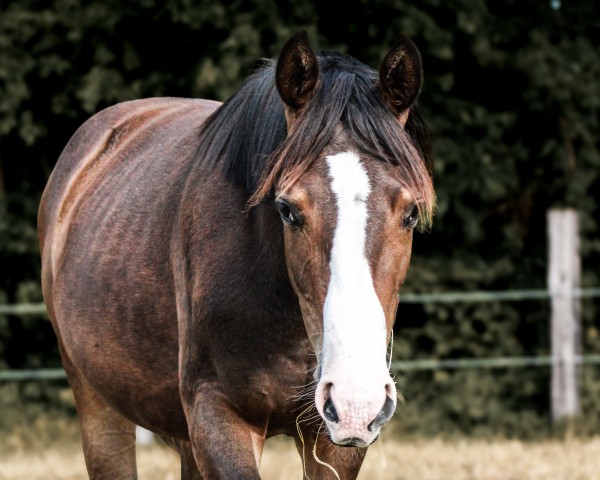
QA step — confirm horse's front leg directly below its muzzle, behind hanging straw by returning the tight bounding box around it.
[294,429,367,480]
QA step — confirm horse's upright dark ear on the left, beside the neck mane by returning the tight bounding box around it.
[275,30,319,110]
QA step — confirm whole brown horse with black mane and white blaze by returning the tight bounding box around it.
[39,32,434,480]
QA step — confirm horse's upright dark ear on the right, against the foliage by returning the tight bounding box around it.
[379,35,423,126]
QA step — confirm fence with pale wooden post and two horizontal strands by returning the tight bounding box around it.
[0,210,600,420]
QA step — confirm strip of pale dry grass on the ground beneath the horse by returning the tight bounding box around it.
[0,438,600,480]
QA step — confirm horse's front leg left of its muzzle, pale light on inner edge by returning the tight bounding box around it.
[182,383,264,480]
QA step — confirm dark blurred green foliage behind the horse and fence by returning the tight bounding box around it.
[0,0,600,478]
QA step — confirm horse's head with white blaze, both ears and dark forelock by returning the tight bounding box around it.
[260,33,434,446]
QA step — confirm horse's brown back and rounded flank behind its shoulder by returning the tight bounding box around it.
[38,98,219,433]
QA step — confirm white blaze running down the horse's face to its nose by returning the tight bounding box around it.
[321,152,391,410]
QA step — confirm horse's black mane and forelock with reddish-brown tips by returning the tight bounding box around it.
[199,51,431,212]
